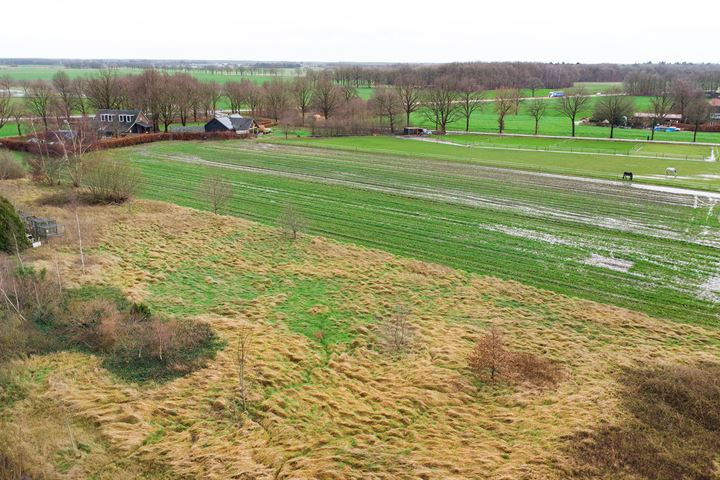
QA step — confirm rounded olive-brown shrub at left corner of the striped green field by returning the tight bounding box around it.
[84,157,140,203]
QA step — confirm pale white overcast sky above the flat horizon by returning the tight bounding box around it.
[0,0,720,63]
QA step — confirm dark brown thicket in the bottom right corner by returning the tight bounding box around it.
[569,363,720,480]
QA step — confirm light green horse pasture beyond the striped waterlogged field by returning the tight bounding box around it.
[268,135,720,191]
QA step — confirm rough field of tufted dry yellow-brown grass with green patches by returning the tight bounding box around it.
[0,181,720,480]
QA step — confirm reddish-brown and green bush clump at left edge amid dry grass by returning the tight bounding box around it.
[0,262,220,381]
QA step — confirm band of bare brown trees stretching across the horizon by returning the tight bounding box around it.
[0,63,720,141]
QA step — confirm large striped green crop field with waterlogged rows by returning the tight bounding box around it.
[105,138,720,323]
